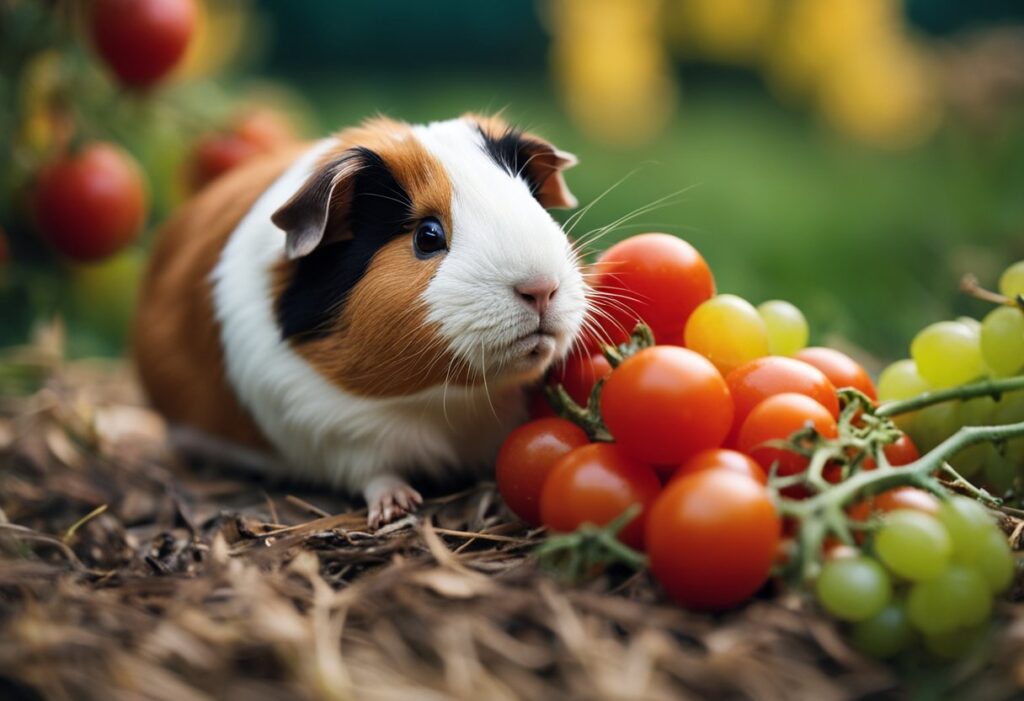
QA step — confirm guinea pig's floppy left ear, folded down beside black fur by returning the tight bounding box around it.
[270,150,364,260]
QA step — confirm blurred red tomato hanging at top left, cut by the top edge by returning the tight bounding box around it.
[90,0,196,86]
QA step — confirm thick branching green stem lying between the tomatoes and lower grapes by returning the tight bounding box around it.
[776,422,1024,580]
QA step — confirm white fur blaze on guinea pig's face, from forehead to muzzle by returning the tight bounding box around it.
[414,119,586,382]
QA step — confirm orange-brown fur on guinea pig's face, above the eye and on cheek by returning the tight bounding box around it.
[273,119,468,397]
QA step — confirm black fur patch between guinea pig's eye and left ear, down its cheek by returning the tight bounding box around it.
[276,148,413,342]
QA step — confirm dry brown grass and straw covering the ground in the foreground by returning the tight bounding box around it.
[0,364,1024,701]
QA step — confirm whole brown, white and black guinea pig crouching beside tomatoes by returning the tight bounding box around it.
[133,115,588,527]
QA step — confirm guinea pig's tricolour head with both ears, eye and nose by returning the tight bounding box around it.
[273,115,587,396]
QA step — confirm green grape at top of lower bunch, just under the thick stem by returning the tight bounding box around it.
[874,509,952,581]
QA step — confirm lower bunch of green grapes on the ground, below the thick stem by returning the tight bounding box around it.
[815,496,1015,658]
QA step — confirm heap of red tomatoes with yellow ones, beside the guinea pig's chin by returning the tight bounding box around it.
[497,233,918,609]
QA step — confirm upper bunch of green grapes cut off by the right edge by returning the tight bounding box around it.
[878,261,1024,493]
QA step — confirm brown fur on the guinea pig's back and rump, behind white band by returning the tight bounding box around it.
[133,145,308,450]
